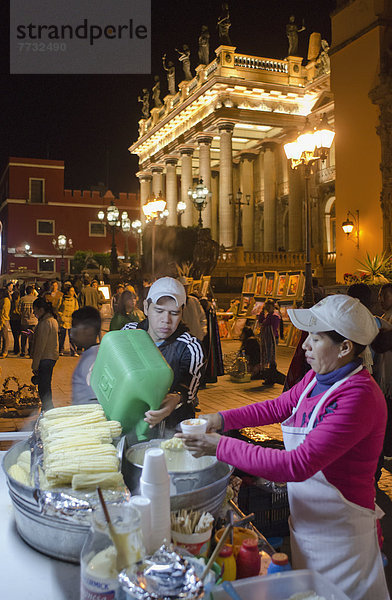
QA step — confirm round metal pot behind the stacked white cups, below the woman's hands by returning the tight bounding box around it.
[122,439,233,515]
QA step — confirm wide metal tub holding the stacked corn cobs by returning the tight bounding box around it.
[3,441,89,563]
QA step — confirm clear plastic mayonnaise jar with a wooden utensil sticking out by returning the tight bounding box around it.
[80,504,145,600]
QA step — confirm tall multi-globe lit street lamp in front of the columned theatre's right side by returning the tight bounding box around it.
[284,114,335,308]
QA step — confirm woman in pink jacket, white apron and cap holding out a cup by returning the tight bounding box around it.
[180,294,389,600]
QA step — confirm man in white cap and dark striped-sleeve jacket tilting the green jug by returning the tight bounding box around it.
[123,277,204,427]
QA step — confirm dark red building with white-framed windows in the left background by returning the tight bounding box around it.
[0,157,140,278]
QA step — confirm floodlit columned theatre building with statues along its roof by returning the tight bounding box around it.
[129,43,336,280]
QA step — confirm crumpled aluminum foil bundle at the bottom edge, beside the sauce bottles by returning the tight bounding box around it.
[119,546,204,600]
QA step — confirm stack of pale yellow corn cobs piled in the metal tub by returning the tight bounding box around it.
[40,404,124,490]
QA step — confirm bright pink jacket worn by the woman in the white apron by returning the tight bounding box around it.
[216,369,387,509]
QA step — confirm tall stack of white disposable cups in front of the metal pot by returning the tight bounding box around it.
[140,448,170,552]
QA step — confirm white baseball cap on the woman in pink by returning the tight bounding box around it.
[287,294,378,346]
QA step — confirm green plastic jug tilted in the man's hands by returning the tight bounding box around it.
[91,329,173,440]
